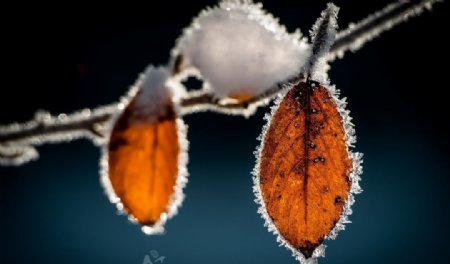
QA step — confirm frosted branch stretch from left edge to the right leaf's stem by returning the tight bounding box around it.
[0,79,296,165]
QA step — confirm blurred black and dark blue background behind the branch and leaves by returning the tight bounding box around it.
[0,0,450,264]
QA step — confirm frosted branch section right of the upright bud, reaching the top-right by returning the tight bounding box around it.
[328,0,441,61]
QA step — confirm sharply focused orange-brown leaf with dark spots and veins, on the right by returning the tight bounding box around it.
[257,82,352,258]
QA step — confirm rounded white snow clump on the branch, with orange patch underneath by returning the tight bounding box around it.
[172,0,310,101]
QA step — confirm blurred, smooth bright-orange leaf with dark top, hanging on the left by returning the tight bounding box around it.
[107,91,185,233]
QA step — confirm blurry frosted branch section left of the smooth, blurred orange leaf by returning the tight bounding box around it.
[0,104,116,165]
